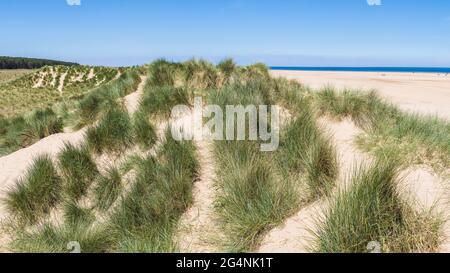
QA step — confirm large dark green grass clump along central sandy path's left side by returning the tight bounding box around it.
[111,131,198,252]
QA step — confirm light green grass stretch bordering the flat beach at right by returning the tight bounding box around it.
[315,87,450,172]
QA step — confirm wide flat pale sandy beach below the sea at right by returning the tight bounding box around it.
[271,70,450,119]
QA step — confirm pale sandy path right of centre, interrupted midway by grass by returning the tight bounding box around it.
[258,119,368,253]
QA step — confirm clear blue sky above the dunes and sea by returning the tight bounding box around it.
[0,0,450,67]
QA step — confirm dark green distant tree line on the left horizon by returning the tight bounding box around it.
[0,56,79,69]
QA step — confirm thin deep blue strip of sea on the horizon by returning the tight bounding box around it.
[270,66,450,74]
